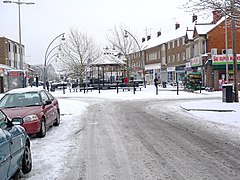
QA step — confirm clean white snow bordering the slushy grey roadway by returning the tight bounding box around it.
[10,85,240,180]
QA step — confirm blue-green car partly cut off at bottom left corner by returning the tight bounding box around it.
[0,110,32,180]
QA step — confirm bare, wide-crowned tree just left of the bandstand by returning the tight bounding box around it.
[59,29,99,83]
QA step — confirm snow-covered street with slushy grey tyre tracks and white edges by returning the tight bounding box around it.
[20,86,240,180]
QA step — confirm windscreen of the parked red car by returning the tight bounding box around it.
[0,92,41,108]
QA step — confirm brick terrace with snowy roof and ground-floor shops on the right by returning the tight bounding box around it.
[130,11,240,90]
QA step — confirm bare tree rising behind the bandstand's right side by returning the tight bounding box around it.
[107,25,139,78]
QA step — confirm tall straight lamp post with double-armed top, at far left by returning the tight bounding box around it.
[3,0,35,70]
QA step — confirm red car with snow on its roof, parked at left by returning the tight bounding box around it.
[0,88,60,137]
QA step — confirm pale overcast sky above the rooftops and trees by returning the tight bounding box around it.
[0,0,201,64]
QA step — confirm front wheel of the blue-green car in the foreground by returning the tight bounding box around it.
[22,144,32,174]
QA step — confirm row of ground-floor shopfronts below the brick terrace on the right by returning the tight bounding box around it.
[145,54,240,90]
